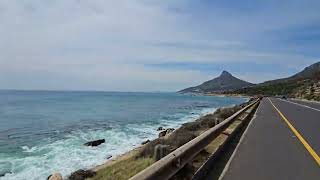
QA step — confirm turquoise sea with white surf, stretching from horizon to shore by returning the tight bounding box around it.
[0,91,246,180]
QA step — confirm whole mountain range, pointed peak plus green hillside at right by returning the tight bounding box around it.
[179,62,320,101]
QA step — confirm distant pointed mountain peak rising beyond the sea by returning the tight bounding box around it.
[179,71,253,93]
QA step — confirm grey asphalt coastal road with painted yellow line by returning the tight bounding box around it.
[222,98,320,180]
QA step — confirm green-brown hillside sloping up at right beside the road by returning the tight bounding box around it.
[232,62,320,101]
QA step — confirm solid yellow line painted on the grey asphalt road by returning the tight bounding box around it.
[268,98,320,166]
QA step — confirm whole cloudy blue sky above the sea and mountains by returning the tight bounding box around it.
[0,0,320,91]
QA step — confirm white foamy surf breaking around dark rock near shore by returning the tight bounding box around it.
[0,108,215,180]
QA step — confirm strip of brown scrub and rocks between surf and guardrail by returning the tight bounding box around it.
[56,100,251,180]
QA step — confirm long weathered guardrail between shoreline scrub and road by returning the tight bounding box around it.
[130,99,259,180]
